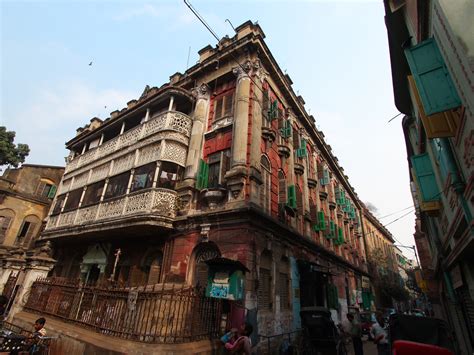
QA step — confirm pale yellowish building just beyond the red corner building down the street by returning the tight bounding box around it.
[362,206,398,307]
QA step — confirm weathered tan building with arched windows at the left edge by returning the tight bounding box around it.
[0,164,64,309]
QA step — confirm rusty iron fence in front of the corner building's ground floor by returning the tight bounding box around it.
[25,278,222,343]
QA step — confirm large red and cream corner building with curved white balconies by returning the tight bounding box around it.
[1,22,380,354]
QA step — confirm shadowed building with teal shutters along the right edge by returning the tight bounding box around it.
[385,0,474,354]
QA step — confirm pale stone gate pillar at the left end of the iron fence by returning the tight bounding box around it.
[7,242,56,321]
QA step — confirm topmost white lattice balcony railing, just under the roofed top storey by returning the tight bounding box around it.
[65,111,192,173]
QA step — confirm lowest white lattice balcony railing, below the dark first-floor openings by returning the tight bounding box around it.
[45,188,177,231]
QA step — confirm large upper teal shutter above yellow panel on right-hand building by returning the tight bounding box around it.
[405,38,461,116]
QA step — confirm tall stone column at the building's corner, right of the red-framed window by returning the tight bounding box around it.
[225,61,251,199]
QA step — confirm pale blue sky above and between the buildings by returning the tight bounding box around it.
[0,0,414,256]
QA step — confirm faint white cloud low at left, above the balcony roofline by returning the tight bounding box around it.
[5,81,134,165]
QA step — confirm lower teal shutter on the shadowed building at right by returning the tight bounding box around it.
[411,153,439,202]
